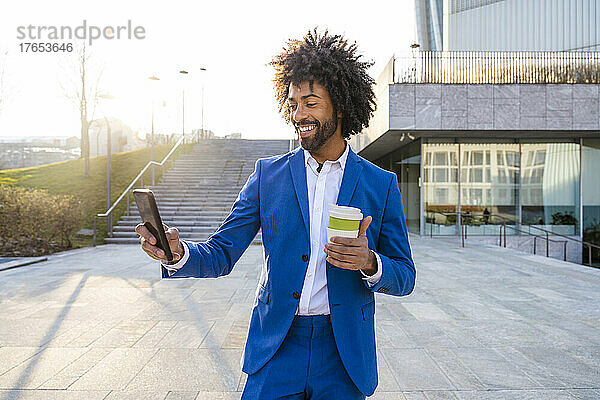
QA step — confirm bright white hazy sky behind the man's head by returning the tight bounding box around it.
[0,0,415,139]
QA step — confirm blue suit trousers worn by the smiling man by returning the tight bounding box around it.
[242,315,365,400]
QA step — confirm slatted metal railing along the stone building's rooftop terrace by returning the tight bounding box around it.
[393,51,600,84]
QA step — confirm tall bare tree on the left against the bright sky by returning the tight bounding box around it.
[61,41,102,178]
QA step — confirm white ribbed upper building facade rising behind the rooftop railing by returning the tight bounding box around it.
[415,0,600,51]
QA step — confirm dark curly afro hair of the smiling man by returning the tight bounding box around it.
[270,28,376,139]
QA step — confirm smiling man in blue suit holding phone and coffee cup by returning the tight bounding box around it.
[136,29,415,400]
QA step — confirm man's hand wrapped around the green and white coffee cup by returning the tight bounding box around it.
[324,216,377,276]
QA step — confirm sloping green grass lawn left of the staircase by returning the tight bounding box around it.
[0,144,192,247]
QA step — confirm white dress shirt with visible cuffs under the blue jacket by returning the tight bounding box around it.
[163,144,382,315]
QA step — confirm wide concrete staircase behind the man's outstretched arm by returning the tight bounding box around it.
[104,139,289,244]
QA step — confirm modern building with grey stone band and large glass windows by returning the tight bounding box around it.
[351,0,600,263]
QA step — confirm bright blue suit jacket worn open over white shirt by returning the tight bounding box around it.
[162,148,416,396]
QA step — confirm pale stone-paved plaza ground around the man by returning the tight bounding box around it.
[0,238,600,400]
